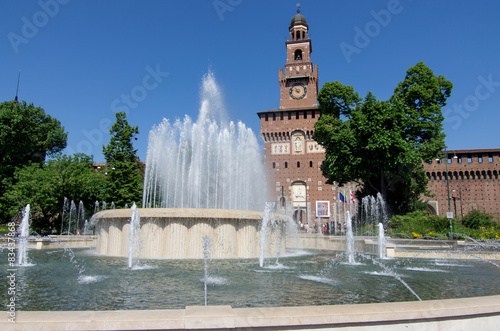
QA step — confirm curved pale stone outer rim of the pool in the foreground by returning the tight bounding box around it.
[5,295,500,331]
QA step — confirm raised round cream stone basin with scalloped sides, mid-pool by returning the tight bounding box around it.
[94,208,285,259]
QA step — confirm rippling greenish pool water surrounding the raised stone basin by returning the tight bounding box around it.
[0,249,500,311]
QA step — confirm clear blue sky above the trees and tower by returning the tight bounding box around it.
[0,0,500,162]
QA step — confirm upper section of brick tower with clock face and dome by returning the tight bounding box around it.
[279,8,318,109]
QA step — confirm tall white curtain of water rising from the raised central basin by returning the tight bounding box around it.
[143,73,265,210]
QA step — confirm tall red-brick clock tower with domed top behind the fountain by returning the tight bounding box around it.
[257,8,337,228]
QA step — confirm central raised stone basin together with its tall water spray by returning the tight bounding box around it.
[94,73,284,258]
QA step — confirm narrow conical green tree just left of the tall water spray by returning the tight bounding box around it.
[102,112,144,207]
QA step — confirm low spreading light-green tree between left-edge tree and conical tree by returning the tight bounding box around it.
[5,154,104,229]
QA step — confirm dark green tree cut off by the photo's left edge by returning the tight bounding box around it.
[0,101,68,219]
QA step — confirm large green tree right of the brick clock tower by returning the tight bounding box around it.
[314,62,452,213]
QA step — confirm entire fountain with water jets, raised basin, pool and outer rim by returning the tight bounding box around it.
[0,75,500,329]
